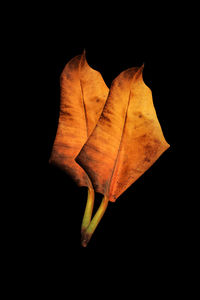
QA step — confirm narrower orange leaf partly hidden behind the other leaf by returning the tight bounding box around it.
[50,52,109,187]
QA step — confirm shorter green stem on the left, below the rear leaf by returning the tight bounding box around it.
[81,187,94,234]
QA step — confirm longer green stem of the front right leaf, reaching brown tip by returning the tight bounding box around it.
[82,196,108,247]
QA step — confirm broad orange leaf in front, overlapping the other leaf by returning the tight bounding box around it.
[76,66,169,202]
